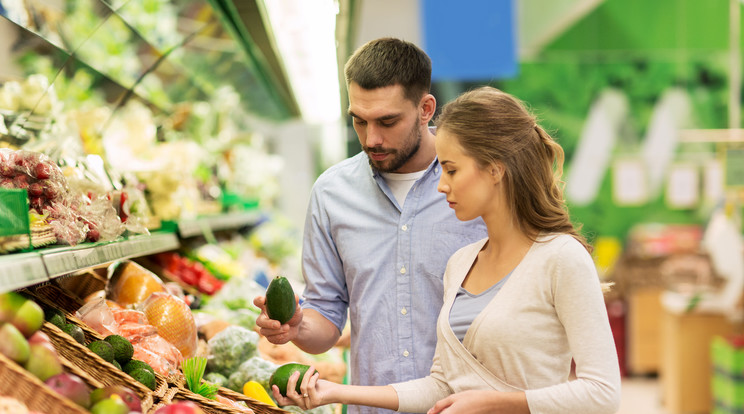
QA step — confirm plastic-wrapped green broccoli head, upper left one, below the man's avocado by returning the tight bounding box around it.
[207,326,258,376]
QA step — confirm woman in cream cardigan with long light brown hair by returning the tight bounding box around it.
[273,87,620,414]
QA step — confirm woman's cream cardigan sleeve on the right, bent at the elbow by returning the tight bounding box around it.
[526,243,620,414]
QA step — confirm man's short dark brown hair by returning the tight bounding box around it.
[344,37,431,103]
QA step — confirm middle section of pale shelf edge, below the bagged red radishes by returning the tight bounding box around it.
[41,233,179,278]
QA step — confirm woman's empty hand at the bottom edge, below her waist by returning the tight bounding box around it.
[426,390,530,414]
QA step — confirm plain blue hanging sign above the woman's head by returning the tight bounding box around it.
[421,0,517,81]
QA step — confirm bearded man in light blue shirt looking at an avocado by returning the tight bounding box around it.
[254,38,486,413]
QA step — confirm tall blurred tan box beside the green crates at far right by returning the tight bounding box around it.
[660,309,734,414]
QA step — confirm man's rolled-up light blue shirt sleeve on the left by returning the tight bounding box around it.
[302,184,349,332]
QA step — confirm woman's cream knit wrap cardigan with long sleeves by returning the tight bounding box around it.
[393,234,620,414]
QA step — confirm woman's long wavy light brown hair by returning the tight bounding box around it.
[435,86,591,251]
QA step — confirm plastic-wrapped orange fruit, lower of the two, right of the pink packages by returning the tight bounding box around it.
[142,292,197,358]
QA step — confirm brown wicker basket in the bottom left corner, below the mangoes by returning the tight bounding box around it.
[0,348,91,414]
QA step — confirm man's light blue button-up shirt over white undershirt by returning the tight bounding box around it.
[302,152,486,413]
